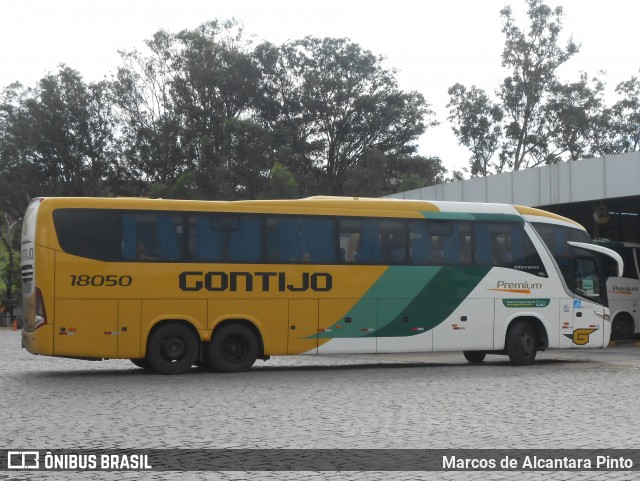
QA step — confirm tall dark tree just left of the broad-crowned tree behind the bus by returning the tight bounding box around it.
[173,20,262,199]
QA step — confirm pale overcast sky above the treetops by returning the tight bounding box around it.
[0,0,640,171]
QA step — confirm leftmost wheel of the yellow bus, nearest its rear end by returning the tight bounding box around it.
[147,322,198,374]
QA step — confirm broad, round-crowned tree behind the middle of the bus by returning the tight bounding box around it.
[256,37,435,194]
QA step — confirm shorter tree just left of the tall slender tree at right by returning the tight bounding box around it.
[447,84,502,177]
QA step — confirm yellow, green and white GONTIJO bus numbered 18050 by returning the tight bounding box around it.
[22,197,621,374]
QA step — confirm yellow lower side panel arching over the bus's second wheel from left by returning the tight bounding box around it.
[207,299,289,356]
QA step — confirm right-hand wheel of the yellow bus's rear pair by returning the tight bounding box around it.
[205,324,259,372]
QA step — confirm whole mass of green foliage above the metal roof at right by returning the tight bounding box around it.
[448,0,640,176]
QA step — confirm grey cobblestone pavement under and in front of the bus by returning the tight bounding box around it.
[0,329,640,481]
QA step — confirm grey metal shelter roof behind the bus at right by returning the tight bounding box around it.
[389,152,640,242]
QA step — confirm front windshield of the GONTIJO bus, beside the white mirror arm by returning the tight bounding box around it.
[532,222,607,306]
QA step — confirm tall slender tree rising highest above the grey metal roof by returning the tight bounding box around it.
[498,0,579,170]
